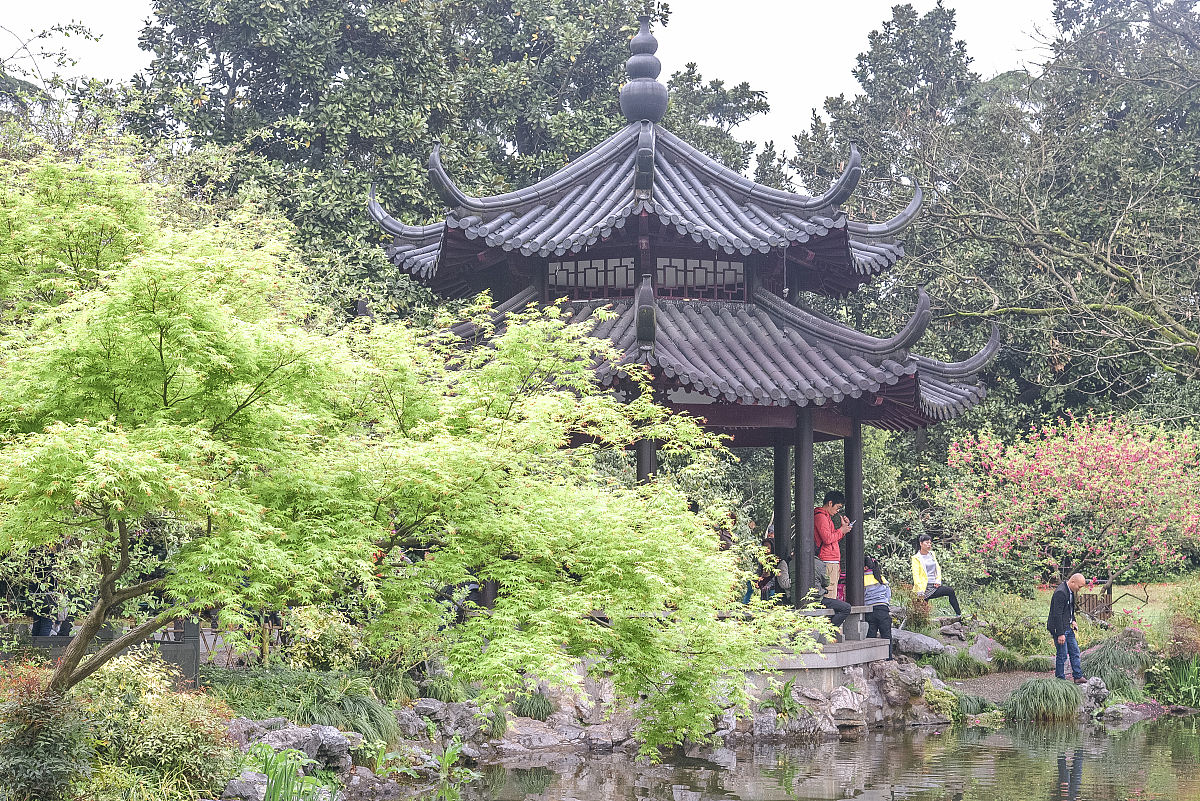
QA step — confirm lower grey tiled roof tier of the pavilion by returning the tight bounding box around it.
[457,289,1000,430]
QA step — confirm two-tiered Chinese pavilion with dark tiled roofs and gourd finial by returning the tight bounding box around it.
[368,17,1000,604]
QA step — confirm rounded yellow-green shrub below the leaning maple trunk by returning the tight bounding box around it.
[73,646,239,800]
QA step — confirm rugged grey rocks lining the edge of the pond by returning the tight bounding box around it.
[222,632,1194,801]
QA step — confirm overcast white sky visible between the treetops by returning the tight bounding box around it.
[0,0,1054,146]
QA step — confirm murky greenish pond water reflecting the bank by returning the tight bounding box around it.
[453,717,1200,801]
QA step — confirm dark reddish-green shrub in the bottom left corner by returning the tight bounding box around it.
[0,664,94,801]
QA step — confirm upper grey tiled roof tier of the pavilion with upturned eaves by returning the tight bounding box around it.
[367,120,922,295]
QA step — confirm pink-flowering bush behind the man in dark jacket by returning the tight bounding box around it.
[936,417,1200,589]
